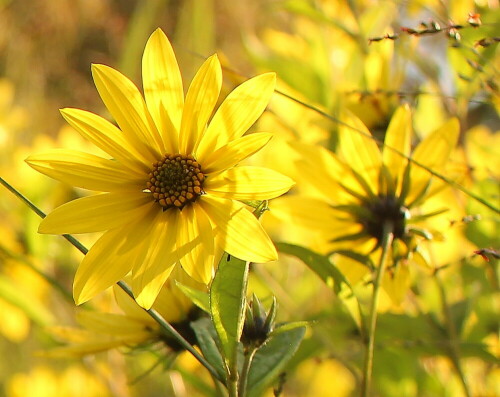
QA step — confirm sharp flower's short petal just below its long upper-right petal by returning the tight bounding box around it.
[196,132,273,174]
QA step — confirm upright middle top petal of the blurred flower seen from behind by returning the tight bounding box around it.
[382,105,412,187]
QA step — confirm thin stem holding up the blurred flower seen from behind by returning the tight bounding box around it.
[361,222,393,397]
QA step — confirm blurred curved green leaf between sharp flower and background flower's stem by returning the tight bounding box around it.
[276,243,352,294]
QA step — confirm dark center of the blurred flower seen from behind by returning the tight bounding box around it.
[360,196,410,245]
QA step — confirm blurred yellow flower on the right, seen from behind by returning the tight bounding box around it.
[272,106,459,284]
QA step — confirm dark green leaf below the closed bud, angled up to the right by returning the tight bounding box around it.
[248,327,306,396]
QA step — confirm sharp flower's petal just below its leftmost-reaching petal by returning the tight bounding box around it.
[38,193,154,234]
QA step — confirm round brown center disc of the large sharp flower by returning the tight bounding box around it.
[146,154,205,211]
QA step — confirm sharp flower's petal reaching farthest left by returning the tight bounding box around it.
[26,149,145,192]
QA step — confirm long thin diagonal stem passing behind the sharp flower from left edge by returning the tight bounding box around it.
[0,177,223,381]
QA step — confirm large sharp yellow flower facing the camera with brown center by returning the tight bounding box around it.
[26,29,293,308]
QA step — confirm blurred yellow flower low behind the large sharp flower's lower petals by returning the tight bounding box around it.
[44,268,206,357]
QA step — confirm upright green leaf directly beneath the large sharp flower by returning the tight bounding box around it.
[210,254,248,370]
